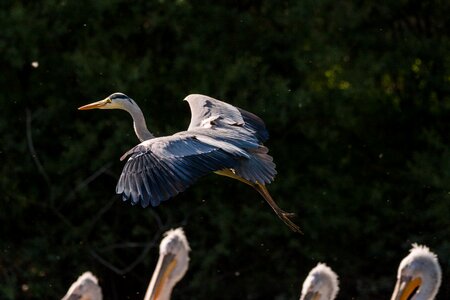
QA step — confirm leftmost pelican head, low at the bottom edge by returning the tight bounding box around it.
[61,272,103,300]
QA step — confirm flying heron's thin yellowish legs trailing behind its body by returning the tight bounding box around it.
[215,169,303,233]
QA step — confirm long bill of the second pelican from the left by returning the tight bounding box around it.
[145,254,177,300]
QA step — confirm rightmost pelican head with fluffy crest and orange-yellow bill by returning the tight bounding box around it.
[391,244,442,300]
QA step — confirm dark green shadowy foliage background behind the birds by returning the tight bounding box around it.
[0,0,450,299]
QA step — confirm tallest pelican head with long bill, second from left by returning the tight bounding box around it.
[144,228,191,300]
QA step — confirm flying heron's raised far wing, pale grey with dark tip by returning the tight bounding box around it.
[185,94,269,143]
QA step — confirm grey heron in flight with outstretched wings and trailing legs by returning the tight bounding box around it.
[78,93,301,232]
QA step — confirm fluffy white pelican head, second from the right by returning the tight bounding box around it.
[300,263,339,300]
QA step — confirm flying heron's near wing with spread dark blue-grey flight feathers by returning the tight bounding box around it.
[116,131,248,207]
